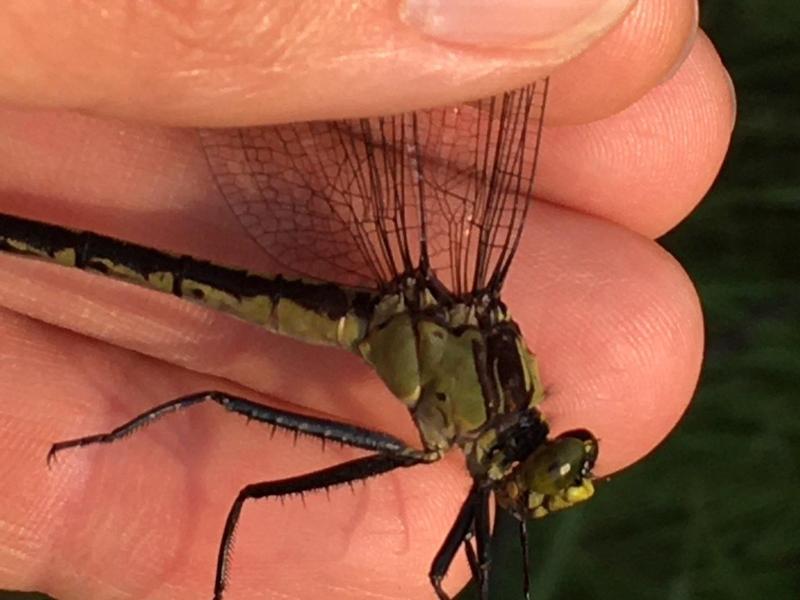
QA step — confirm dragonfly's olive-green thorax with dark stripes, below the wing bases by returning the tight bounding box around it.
[358,278,546,478]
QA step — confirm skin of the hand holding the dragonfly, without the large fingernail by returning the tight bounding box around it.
[0,0,735,600]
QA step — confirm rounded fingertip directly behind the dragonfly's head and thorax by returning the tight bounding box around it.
[503,204,703,473]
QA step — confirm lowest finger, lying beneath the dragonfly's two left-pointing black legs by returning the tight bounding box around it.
[0,311,476,600]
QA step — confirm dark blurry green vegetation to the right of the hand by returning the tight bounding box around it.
[0,0,800,600]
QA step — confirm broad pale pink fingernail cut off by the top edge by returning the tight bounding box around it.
[400,0,635,46]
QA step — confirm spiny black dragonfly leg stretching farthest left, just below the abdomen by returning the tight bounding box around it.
[47,390,432,464]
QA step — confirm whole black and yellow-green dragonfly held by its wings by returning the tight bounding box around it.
[0,79,599,600]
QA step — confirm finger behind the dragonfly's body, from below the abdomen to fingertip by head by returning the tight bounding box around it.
[0,205,702,471]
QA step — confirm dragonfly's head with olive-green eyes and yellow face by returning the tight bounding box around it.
[495,429,598,519]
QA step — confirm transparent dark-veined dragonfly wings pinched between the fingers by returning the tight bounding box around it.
[200,81,546,296]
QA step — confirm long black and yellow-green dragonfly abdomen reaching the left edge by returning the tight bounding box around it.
[0,215,374,350]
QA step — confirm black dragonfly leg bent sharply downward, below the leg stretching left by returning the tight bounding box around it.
[214,454,427,600]
